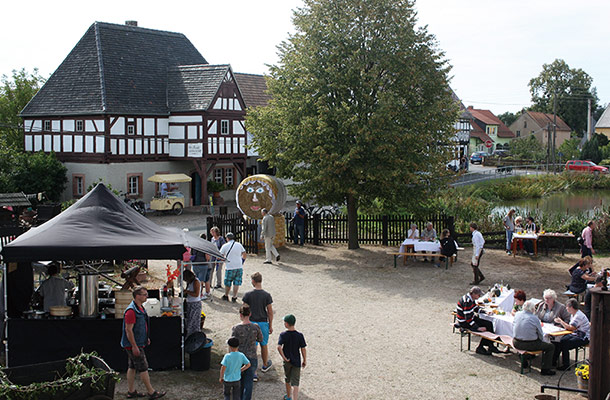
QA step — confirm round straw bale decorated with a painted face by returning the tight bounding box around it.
[235,175,286,219]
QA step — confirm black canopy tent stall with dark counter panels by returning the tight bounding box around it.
[2,184,223,371]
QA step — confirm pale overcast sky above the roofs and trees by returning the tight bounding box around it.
[0,0,610,114]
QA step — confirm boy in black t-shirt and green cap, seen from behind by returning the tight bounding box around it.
[277,314,307,400]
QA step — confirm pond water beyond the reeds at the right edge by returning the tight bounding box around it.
[494,190,610,214]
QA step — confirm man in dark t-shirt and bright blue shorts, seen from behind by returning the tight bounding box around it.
[243,272,273,378]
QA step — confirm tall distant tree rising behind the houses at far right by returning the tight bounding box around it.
[529,59,598,137]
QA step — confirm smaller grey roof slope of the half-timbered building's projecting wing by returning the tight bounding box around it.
[167,65,231,112]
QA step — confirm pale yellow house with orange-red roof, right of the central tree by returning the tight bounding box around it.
[467,106,515,153]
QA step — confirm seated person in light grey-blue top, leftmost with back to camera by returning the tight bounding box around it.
[513,300,555,375]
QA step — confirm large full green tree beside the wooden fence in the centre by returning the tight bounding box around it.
[247,0,458,249]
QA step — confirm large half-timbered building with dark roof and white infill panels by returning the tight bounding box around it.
[21,22,248,204]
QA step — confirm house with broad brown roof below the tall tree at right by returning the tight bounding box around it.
[509,111,572,148]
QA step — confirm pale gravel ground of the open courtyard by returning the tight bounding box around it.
[117,239,610,400]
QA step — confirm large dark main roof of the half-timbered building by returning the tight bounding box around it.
[21,22,207,117]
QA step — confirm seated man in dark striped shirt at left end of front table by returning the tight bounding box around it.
[455,286,500,356]
